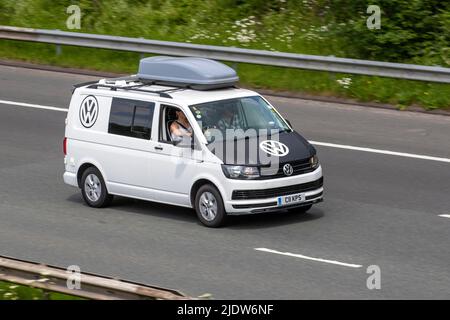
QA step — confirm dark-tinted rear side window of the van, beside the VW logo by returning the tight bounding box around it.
[108,98,155,140]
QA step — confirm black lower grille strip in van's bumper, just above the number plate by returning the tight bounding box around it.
[231,177,323,200]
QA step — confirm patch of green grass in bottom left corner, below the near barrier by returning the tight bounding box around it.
[0,281,84,300]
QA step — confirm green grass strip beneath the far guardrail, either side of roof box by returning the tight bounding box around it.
[0,40,450,110]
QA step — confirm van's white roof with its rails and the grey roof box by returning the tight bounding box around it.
[75,56,257,105]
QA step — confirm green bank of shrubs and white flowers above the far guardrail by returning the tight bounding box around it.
[0,0,450,65]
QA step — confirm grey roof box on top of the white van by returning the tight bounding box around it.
[137,56,239,90]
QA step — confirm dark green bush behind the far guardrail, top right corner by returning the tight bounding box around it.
[329,0,450,66]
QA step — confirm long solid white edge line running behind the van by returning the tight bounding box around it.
[0,100,450,163]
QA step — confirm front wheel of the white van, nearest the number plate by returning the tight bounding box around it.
[195,184,227,228]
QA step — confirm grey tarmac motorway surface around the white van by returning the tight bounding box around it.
[0,66,450,299]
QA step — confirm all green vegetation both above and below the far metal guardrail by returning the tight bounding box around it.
[0,0,450,109]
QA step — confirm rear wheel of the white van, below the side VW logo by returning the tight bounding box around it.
[81,167,113,208]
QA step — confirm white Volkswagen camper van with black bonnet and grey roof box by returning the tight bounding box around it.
[64,57,323,227]
